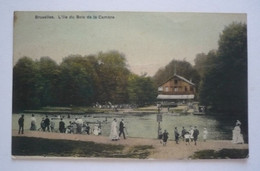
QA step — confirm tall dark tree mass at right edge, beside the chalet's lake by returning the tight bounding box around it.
[200,23,247,120]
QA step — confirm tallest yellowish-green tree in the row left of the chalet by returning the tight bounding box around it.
[98,51,130,103]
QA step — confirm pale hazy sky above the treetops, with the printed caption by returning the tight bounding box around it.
[13,12,247,76]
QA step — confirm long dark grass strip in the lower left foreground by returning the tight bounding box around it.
[12,136,153,159]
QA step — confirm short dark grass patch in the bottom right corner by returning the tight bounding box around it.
[190,149,248,159]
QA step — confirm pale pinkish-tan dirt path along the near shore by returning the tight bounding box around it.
[12,131,248,160]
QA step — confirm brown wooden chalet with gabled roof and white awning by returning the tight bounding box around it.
[157,74,196,102]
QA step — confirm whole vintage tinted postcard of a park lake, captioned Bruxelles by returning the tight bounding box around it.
[11,11,249,160]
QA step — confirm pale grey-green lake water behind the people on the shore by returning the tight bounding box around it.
[12,113,234,140]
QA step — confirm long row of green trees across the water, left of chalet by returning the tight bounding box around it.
[13,51,156,111]
